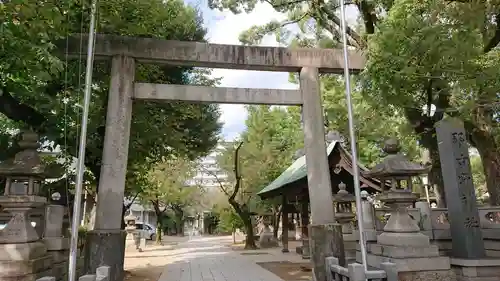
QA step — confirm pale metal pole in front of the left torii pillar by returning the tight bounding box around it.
[68,0,97,281]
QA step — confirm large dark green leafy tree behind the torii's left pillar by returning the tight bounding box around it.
[0,0,221,201]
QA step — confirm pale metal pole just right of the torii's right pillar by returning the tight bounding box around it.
[340,0,368,271]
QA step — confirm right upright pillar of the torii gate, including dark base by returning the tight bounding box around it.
[299,67,343,281]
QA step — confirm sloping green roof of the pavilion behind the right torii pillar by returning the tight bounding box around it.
[257,141,337,195]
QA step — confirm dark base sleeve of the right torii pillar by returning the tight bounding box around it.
[309,223,345,281]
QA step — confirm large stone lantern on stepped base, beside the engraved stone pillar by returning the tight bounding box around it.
[357,139,451,280]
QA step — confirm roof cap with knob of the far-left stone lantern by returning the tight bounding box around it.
[0,131,45,177]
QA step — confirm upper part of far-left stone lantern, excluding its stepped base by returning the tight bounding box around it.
[0,131,47,243]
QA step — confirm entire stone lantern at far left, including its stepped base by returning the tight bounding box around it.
[0,131,52,280]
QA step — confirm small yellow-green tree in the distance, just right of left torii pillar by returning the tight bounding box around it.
[140,157,202,243]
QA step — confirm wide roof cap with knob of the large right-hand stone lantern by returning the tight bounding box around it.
[364,138,430,179]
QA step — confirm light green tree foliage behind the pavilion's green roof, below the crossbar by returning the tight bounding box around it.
[218,105,303,212]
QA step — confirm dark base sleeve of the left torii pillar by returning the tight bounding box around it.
[84,230,127,281]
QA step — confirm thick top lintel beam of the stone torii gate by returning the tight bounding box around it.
[59,34,365,73]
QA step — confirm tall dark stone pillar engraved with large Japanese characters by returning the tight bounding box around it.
[436,118,500,281]
